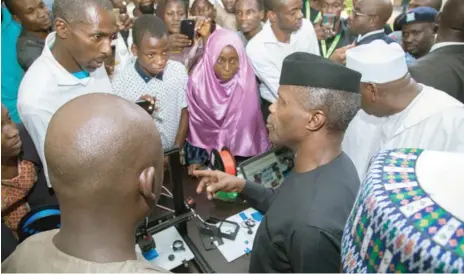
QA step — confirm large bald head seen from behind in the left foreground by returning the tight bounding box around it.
[45,93,164,222]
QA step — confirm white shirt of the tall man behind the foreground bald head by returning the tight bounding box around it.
[18,32,111,187]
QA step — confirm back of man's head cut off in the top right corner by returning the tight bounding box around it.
[437,0,464,42]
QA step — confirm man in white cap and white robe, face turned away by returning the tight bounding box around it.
[343,40,464,180]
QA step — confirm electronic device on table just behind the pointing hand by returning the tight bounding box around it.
[238,148,295,188]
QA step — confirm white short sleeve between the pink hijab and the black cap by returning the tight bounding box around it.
[246,43,281,98]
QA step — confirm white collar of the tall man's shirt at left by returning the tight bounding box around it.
[41,32,94,86]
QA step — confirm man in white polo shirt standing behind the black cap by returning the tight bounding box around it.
[246,0,319,119]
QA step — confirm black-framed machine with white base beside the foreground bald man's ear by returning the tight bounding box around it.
[135,148,214,273]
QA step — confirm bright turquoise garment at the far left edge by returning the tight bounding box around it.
[1,6,24,123]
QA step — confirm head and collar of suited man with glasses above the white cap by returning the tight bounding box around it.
[348,0,395,45]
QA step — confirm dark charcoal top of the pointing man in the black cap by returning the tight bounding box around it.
[242,153,360,273]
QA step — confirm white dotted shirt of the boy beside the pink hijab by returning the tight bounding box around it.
[113,61,188,149]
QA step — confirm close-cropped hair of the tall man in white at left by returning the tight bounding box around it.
[52,0,113,24]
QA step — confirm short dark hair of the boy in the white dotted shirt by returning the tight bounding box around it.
[132,14,168,47]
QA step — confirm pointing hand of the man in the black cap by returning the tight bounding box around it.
[193,170,246,200]
